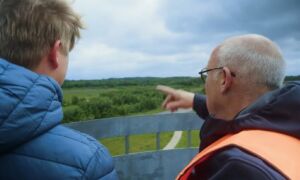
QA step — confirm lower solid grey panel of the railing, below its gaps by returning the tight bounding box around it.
[114,148,198,180]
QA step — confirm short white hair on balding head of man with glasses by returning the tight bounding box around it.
[217,34,285,89]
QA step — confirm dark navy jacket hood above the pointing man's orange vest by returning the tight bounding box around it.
[200,82,300,149]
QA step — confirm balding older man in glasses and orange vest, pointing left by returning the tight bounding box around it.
[157,35,300,179]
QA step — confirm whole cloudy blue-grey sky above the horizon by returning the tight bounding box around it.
[67,0,300,79]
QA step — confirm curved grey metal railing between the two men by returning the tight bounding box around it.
[66,112,203,180]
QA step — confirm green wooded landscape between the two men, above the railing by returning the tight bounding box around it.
[63,77,203,123]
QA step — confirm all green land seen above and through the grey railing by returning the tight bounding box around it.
[63,77,203,155]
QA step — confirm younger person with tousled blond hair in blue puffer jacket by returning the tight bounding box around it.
[0,0,117,180]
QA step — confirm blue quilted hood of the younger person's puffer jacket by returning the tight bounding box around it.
[0,59,63,154]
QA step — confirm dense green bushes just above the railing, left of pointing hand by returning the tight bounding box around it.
[63,87,163,123]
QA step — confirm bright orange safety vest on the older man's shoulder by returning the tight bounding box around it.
[176,130,300,180]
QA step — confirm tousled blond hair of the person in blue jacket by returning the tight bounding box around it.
[0,0,83,69]
